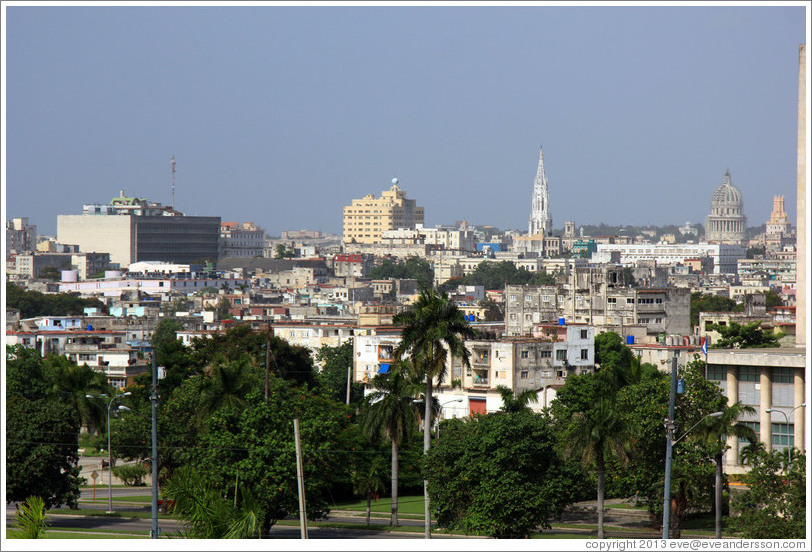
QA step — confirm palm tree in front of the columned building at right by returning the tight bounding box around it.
[692,402,759,539]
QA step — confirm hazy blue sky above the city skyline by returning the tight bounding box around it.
[4,3,807,235]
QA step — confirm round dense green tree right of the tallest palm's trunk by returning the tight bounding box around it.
[424,412,580,538]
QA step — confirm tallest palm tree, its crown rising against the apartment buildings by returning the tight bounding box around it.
[392,289,476,538]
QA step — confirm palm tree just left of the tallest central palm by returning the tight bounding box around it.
[359,364,426,527]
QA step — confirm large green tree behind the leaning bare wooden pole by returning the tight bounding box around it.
[189,377,357,534]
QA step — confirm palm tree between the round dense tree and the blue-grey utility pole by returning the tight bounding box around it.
[566,400,630,539]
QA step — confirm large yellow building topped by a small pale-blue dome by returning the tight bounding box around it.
[344,178,423,244]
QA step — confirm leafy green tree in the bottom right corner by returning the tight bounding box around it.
[728,450,807,539]
